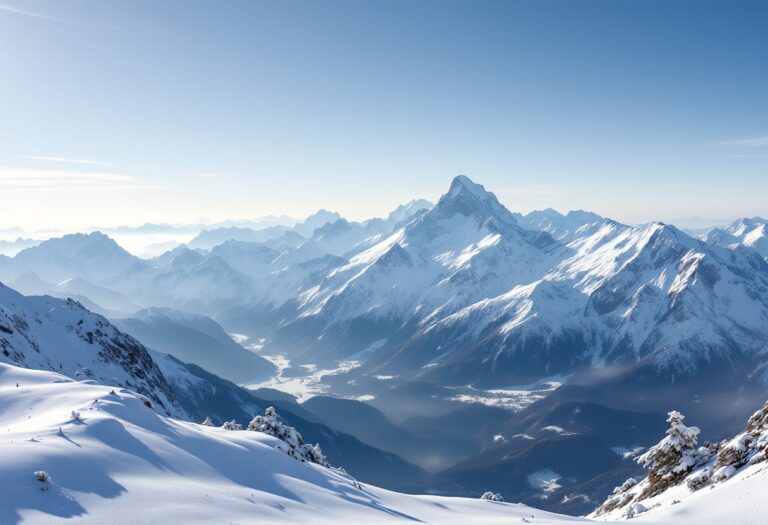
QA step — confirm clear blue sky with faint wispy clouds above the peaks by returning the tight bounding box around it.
[0,0,768,229]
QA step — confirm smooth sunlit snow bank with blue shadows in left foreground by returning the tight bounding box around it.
[0,364,583,525]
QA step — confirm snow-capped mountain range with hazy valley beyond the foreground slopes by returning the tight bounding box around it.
[0,176,768,513]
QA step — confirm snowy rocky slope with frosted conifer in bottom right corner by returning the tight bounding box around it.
[592,404,768,524]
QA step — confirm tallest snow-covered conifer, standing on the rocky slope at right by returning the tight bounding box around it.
[637,410,699,499]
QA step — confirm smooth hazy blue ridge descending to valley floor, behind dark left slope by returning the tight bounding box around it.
[112,308,275,383]
